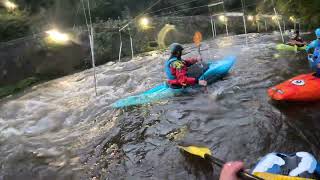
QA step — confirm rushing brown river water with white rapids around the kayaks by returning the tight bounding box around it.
[0,34,320,179]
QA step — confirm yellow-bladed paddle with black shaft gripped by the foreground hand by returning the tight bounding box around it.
[179,146,263,180]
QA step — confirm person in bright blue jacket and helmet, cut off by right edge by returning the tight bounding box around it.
[306,28,320,77]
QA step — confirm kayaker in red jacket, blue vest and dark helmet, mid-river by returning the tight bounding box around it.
[165,43,207,88]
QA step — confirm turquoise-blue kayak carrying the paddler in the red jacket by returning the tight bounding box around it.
[111,56,236,108]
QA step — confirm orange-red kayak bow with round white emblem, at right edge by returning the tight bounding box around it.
[268,73,320,101]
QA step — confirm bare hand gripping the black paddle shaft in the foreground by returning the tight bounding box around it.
[220,161,244,180]
